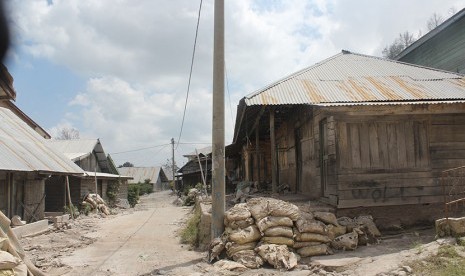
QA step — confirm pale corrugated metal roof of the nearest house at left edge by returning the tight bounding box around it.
[0,107,84,174]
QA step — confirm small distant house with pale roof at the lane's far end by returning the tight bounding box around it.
[118,167,169,191]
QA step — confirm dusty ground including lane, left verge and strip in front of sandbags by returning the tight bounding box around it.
[21,191,438,276]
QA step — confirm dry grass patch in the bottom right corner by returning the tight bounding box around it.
[409,245,465,276]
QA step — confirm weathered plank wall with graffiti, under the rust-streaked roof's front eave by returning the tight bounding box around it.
[337,111,465,208]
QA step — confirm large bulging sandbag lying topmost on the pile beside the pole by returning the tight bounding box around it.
[247,197,300,221]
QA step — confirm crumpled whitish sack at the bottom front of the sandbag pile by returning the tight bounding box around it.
[255,244,297,270]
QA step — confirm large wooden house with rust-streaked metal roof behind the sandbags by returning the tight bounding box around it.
[233,51,465,224]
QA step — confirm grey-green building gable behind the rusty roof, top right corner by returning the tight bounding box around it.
[396,9,465,74]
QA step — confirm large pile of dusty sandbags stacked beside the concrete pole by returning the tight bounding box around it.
[213,197,381,269]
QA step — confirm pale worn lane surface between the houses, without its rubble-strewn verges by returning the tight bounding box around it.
[62,191,203,275]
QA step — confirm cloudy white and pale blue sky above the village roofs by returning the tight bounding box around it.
[7,0,465,166]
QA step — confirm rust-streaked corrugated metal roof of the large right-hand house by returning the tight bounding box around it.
[245,51,465,106]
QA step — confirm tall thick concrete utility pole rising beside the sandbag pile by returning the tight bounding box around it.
[211,0,225,239]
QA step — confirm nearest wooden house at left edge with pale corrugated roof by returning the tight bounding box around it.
[0,65,84,222]
